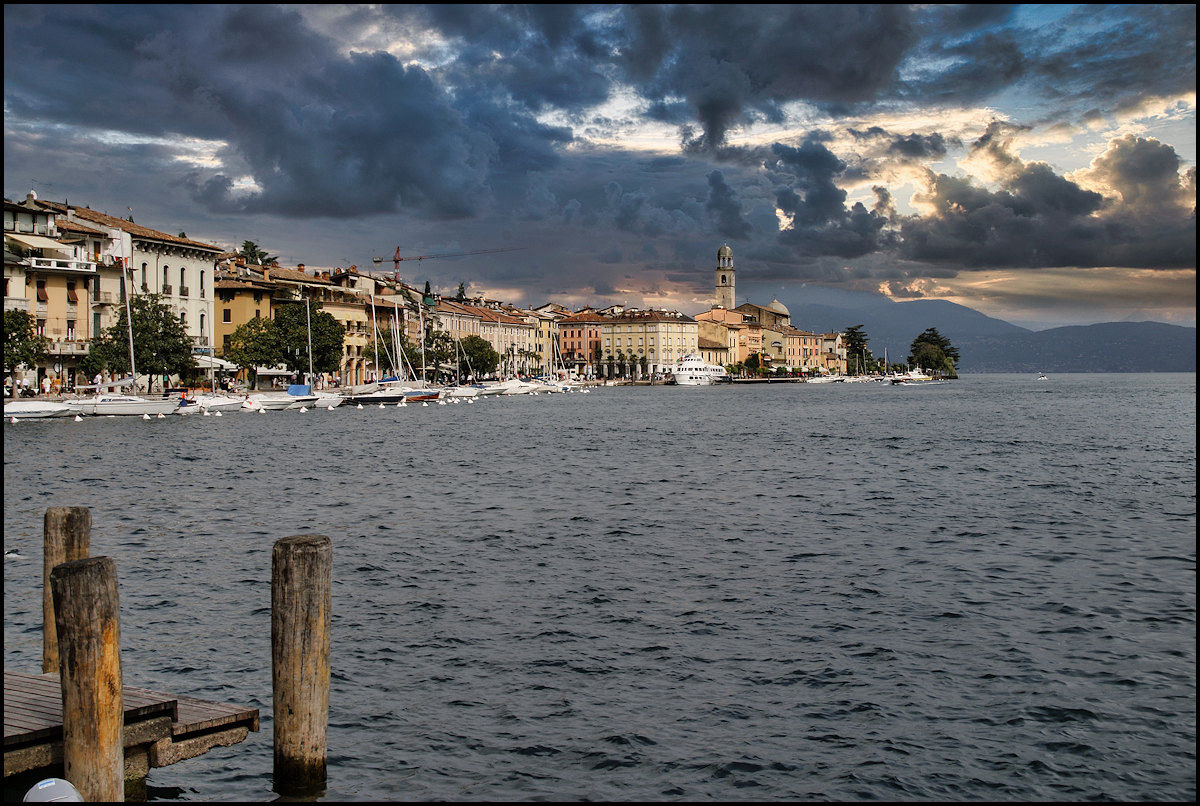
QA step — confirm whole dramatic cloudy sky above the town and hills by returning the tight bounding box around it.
[4,5,1196,327]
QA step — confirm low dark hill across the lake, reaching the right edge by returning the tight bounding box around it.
[950,321,1196,373]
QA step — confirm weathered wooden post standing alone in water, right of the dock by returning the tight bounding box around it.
[271,535,334,794]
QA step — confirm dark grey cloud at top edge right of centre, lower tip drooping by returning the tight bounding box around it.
[612,5,914,149]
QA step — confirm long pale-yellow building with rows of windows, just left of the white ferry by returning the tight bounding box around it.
[600,309,698,378]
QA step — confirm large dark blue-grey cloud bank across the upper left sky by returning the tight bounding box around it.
[5,6,570,218]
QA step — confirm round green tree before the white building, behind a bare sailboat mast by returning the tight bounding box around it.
[96,294,196,390]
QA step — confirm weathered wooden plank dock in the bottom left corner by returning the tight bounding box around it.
[4,669,258,781]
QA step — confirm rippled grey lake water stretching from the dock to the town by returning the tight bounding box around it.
[4,374,1196,801]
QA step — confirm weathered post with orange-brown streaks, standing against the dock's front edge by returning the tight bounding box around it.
[50,557,125,802]
